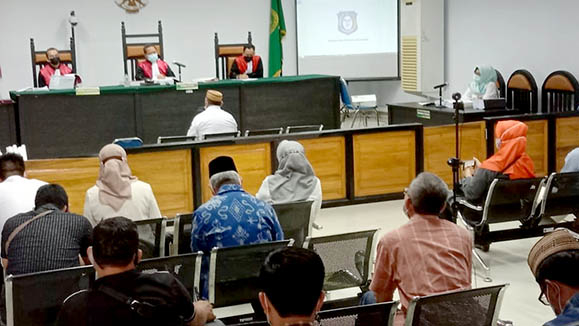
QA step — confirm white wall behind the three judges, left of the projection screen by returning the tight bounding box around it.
[0,0,296,98]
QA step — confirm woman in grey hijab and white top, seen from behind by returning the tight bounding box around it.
[255,140,322,230]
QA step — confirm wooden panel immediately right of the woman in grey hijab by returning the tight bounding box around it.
[298,137,346,200]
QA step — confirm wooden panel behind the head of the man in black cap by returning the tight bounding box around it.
[199,143,272,202]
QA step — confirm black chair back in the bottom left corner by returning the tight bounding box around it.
[5,266,95,326]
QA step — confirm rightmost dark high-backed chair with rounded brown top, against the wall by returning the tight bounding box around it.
[541,70,579,113]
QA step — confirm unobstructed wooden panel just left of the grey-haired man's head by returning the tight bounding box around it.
[353,131,416,197]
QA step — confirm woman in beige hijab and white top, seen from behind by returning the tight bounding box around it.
[84,144,161,225]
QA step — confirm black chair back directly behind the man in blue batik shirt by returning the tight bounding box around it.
[209,240,290,307]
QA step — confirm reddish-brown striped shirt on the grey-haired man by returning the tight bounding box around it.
[370,215,472,312]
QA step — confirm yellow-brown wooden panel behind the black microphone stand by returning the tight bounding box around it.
[424,121,487,186]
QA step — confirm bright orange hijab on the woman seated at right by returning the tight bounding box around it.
[480,120,535,180]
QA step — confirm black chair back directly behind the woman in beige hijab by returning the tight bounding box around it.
[135,217,167,259]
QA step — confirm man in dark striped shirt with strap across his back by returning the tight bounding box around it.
[2,184,92,275]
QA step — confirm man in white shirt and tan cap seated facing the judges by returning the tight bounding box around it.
[187,90,237,140]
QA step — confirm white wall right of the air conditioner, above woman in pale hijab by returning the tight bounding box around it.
[445,0,579,103]
